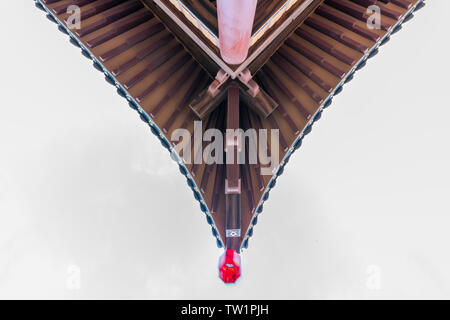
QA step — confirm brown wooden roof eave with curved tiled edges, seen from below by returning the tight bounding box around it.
[35,0,423,282]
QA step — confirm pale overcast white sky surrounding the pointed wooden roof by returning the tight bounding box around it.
[0,0,450,299]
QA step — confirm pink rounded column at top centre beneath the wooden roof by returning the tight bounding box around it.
[217,0,257,65]
